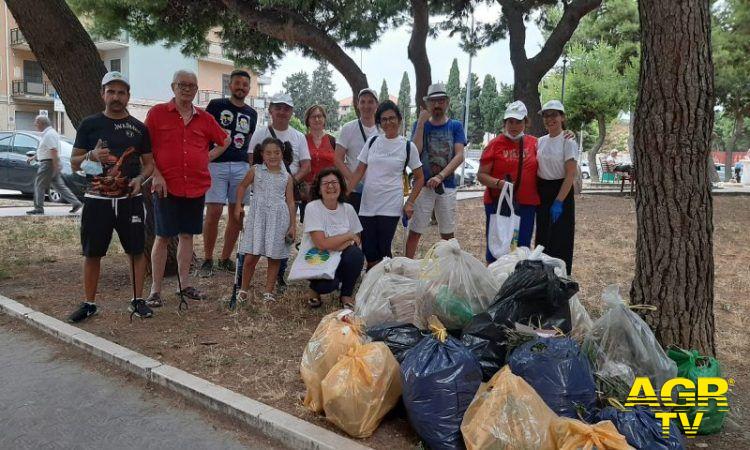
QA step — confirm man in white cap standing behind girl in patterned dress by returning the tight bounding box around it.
[247,93,310,291]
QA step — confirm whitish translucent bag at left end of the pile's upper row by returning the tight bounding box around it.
[354,273,428,329]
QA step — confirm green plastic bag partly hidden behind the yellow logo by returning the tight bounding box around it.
[667,346,727,434]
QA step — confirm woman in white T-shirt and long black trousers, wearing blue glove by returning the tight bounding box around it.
[536,100,578,274]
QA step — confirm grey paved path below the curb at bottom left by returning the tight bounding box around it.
[0,317,278,450]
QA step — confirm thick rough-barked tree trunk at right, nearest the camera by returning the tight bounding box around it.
[630,0,716,354]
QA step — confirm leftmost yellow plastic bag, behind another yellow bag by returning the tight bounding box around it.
[300,310,364,412]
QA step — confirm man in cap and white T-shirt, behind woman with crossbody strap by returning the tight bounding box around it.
[334,88,378,213]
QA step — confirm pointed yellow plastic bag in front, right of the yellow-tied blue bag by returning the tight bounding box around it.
[461,366,557,450]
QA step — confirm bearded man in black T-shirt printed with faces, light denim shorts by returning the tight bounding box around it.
[198,70,258,277]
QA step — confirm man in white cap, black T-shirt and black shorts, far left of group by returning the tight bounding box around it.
[68,72,154,322]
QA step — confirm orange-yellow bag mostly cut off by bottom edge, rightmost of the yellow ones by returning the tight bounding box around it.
[552,417,633,450]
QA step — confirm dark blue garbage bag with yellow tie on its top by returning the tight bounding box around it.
[401,318,482,450]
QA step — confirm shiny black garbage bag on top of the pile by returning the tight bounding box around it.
[461,260,578,381]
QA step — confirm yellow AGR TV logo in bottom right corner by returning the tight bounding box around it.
[625,377,734,438]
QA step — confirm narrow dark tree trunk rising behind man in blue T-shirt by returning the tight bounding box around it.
[408,0,432,110]
